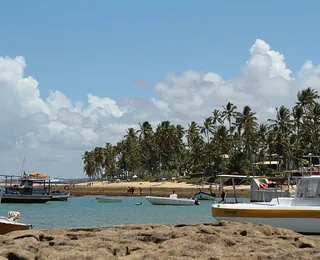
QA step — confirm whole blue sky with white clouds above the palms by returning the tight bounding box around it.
[0,0,320,178]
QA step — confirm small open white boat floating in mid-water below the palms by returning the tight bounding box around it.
[146,194,199,206]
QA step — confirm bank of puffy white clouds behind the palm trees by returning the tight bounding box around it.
[0,39,320,177]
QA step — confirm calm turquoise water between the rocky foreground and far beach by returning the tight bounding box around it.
[0,196,215,229]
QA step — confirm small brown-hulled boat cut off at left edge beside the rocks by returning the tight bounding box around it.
[0,211,32,235]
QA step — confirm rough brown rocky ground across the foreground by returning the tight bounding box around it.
[0,222,320,260]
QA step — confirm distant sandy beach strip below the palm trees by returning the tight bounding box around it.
[55,181,250,197]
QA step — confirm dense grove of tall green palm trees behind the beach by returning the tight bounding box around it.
[83,88,320,181]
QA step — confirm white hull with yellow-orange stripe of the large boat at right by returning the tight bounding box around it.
[212,204,320,234]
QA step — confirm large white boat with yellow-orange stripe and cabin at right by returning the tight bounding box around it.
[211,175,320,234]
